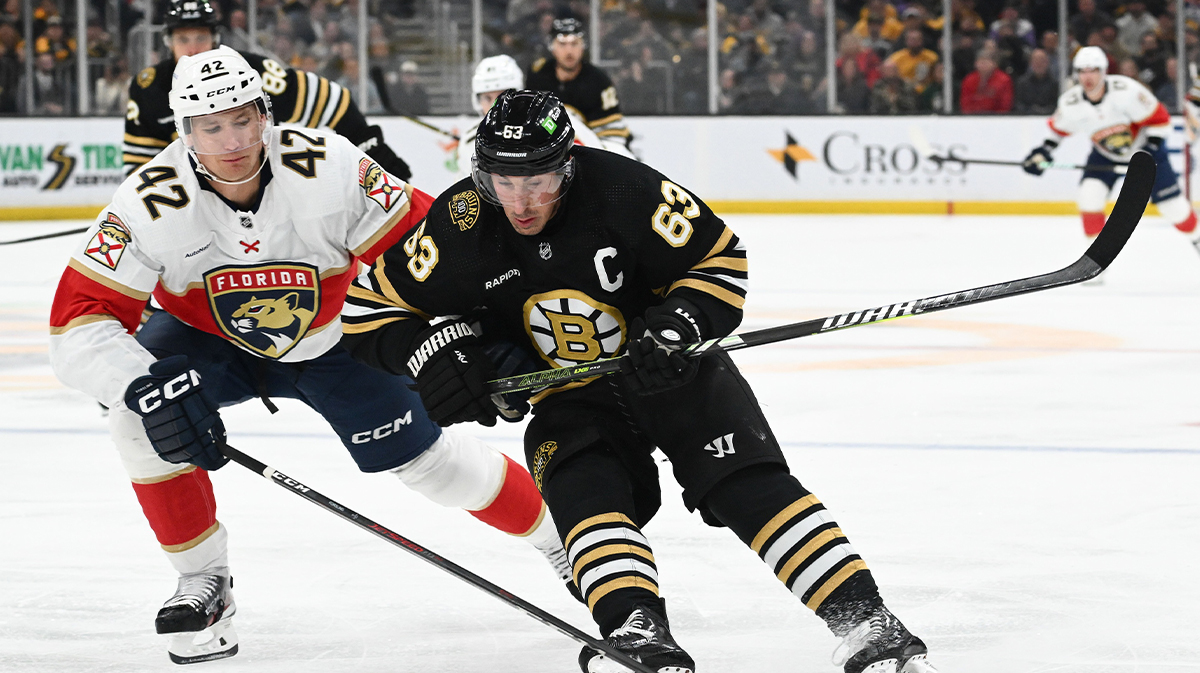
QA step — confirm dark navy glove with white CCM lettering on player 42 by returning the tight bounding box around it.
[125,355,229,471]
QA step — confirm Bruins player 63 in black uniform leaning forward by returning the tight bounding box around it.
[342,90,934,673]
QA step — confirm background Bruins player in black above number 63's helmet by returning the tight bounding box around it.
[526,18,634,155]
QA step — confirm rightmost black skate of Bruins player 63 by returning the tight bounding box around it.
[833,605,937,673]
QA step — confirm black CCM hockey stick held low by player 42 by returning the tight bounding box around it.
[220,441,655,673]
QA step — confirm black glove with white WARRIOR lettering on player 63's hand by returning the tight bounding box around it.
[408,320,498,427]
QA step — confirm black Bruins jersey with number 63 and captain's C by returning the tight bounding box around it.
[342,148,746,402]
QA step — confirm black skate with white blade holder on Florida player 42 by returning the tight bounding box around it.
[154,567,238,663]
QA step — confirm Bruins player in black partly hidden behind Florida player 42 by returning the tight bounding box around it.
[125,0,413,181]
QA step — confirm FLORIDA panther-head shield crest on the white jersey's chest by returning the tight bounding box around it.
[204,263,320,359]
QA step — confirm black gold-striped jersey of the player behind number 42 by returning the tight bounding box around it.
[125,52,372,175]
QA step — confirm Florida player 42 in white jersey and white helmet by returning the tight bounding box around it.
[50,47,569,663]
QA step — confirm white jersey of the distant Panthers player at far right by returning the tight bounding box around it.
[1050,74,1171,163]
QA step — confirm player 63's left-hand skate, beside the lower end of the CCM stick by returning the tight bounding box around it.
[580,605,696,673]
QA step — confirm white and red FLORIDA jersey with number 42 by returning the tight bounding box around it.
[50,127,432,405]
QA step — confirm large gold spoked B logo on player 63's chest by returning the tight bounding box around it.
[524,290,625,367]
